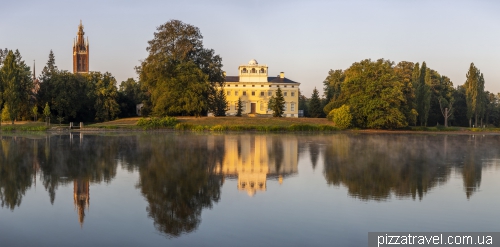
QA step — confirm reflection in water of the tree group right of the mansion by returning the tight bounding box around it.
[324,134,498,200]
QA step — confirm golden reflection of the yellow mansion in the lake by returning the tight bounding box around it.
[214,135,298,196]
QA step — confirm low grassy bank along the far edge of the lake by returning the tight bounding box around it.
[0,117,500,133]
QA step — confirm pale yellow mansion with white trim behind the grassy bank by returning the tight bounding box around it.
[224,59,300,117]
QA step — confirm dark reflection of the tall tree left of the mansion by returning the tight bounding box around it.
[137,135,224,237]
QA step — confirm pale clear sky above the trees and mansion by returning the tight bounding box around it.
[0,0,500,96]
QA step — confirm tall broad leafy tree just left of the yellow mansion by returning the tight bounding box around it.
[136,20,227,116]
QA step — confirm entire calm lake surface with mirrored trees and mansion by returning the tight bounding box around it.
[0,132,500,246]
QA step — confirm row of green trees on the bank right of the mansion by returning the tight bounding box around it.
[299,59,500,129]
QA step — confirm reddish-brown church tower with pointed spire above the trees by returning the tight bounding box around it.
[73,20,89,73]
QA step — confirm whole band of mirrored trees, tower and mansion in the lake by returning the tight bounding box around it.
[0,133,500,237]
